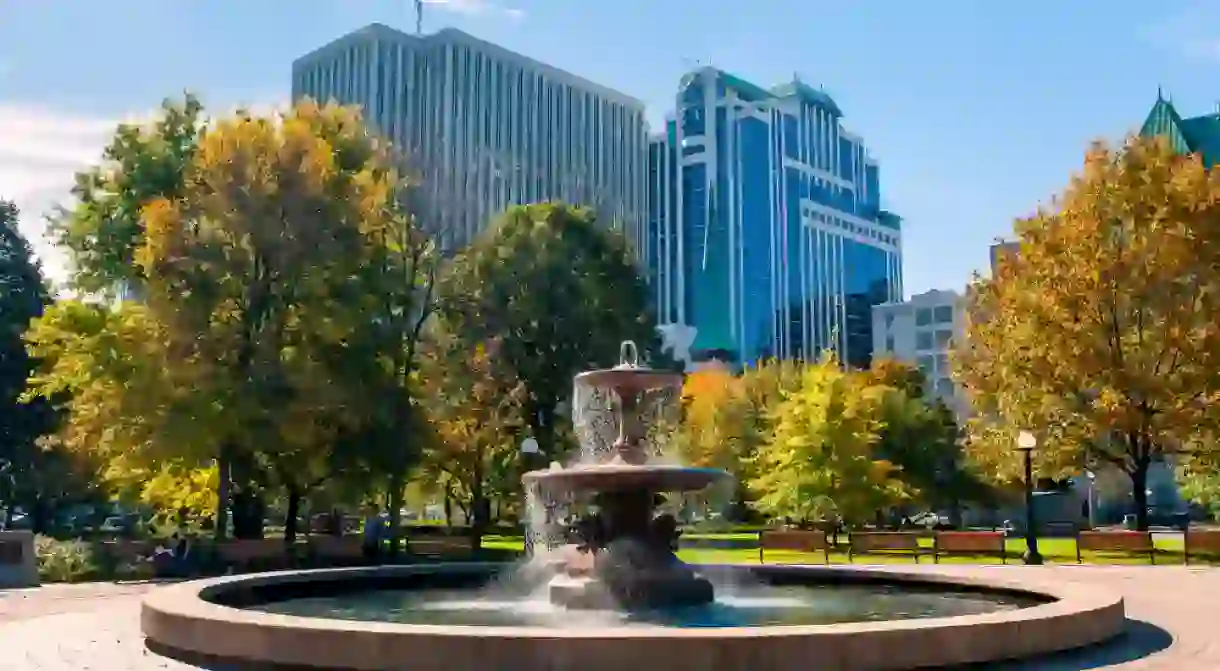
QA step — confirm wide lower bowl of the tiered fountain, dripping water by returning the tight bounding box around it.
[521,462,728,492]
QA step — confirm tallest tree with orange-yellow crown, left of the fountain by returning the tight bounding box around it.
[135,101,399,538]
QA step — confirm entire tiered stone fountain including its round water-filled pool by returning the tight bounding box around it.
[140,343,1124,671]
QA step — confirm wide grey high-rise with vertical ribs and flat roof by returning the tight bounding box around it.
[293,23,648,246]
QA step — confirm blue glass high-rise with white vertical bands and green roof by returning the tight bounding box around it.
[642,67,903,366]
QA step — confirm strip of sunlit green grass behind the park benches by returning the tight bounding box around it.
[483,533,1203,565]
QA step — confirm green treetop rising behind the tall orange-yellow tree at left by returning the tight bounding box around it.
[49,93,204,294]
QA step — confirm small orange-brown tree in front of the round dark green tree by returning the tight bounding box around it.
[421,334,525,550]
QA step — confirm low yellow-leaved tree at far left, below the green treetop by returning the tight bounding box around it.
[24,300,187,531]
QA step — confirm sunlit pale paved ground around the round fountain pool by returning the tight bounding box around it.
[0,565,1220,671]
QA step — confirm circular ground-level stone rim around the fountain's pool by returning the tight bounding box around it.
[140,564,1125,671]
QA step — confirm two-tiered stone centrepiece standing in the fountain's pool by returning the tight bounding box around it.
[523,340,728,610]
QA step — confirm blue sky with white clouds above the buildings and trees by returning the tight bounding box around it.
[0,0,1220,294]
